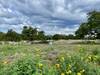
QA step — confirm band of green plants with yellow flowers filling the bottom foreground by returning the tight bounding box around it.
[0,50,100,75]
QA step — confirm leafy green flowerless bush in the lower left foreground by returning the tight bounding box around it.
[6,59,36,75]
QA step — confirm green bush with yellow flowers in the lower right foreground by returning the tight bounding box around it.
[57,55,100,75]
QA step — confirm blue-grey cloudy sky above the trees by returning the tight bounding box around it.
[0,0,100,34]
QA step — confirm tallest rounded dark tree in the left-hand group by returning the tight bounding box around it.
[22,26,45,41]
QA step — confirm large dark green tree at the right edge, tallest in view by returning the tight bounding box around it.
[75,11,100,39]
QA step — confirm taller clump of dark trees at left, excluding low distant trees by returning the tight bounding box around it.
[0,26,46,41]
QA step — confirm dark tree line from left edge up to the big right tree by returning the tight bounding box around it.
[0,26,74,41]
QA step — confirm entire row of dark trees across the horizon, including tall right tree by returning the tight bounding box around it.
[0,11,100,41]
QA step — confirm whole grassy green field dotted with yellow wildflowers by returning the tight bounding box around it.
[0,42,100,75]
